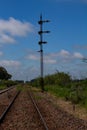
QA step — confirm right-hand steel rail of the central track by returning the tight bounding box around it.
[28,91,48,130]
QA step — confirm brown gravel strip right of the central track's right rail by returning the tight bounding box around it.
[30,89,87,130]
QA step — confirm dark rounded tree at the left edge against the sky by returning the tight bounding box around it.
[0,66,12,80]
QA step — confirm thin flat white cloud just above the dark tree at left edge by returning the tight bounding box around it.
[0,60,21,67]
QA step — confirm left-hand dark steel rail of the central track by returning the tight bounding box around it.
[0,91,20,124]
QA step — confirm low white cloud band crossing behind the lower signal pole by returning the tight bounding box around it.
[26,49,84,64]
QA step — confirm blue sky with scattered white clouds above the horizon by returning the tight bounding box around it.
[0,0,87,80]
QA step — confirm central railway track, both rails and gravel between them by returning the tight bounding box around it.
[0,86,48,130]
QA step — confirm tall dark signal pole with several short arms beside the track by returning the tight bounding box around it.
[38,15,50,92]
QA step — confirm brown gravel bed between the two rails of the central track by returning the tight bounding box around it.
[0,91,44,130]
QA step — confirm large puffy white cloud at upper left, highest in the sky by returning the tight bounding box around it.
[0,17,34,43]
